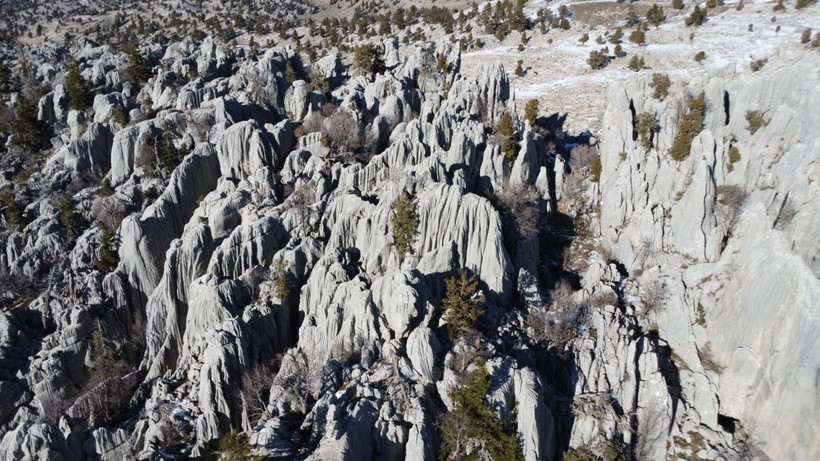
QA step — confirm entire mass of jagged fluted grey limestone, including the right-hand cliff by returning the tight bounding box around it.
[0,27,820,461]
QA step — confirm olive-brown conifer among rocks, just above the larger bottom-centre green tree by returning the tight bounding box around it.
[441,269,484,341]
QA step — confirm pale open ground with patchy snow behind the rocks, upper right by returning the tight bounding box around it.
[462,0,820,132]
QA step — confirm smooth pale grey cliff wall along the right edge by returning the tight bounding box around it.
[598,53,820,459]
